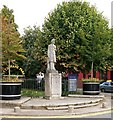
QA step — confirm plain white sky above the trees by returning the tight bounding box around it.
[0,0,113,34]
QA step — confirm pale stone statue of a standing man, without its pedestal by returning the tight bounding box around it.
[47,39,56,71]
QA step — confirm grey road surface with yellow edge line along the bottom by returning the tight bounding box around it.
[2,110,113,120]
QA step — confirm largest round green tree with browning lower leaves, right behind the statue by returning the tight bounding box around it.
[37,1,110,73]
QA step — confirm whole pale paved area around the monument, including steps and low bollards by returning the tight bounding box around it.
[0,93,113,116]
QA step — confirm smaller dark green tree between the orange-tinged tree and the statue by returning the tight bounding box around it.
[22,26,44,77]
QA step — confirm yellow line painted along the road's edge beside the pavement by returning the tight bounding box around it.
[0,109,113,119]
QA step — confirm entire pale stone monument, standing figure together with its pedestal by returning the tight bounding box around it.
[45,39,62,99]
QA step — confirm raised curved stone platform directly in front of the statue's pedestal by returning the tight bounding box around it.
[21,97,103,109]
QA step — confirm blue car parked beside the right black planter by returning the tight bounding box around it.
[100,82,113,92]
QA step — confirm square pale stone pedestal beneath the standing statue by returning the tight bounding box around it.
[45,72,62,100]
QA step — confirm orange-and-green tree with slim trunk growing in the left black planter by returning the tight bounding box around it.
[0,6,25,79]
